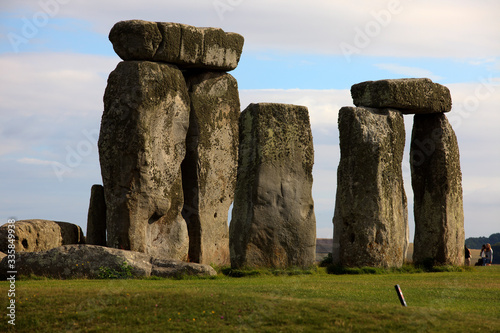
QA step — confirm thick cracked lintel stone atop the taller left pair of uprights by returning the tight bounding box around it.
[109,20,244,71]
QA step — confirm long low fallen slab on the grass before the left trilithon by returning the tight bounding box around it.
[0,245,217,279]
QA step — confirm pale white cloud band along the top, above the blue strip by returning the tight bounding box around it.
[2,0,500,58]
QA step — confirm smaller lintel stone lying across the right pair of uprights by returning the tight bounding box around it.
[351,79,451,114]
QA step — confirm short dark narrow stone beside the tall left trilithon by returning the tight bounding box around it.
[85,184,106,246]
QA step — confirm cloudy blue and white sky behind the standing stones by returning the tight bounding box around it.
[0,0,500,240]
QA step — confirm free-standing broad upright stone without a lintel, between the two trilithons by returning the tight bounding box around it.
[229,103,316,267]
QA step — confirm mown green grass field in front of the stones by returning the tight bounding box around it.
[0,266,500,332]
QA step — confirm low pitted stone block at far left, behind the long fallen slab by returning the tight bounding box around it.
[0,220,85,253]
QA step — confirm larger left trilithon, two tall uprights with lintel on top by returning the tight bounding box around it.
[99,20,244,264]
